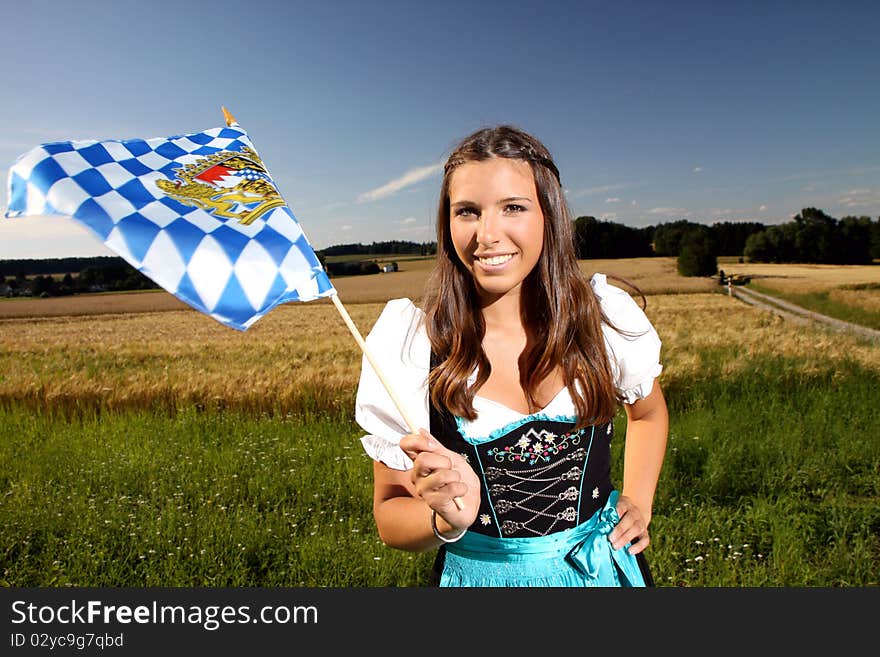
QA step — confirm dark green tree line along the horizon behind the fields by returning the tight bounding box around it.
[0,207,880,296]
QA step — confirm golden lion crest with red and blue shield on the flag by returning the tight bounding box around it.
[156,146,284,226]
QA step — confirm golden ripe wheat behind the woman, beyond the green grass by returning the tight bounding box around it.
[0,262,880,411]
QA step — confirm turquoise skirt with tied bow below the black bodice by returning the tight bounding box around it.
[440,490,646,587]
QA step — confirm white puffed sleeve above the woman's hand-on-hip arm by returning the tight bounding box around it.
[590,274,663,404]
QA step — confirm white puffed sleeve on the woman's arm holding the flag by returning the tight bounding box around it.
[355,299,431,470]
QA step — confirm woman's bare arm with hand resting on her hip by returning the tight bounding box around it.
[609,380,669,554]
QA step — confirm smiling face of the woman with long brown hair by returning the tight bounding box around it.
[449,157,544,300]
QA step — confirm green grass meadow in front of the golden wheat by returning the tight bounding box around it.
[0,348,880,587]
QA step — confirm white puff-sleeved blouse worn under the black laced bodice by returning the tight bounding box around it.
[355,274,663,470]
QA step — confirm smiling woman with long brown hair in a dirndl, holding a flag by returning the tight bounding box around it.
[356,126,668,586]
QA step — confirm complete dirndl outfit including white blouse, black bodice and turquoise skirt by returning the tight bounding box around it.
[355,273,662,586]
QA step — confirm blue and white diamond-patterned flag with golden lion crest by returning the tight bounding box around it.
[6,109,336,331]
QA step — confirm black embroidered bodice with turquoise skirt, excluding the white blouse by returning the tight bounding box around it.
[431,382,653,587]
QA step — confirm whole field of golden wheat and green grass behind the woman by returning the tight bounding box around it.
[0,259,880,587]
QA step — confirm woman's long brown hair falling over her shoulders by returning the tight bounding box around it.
[422,125,631,427]
